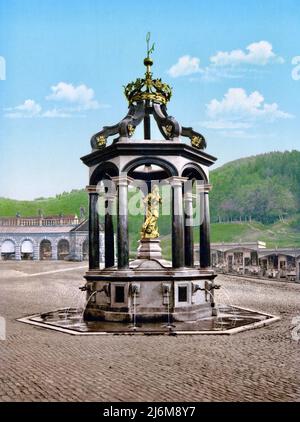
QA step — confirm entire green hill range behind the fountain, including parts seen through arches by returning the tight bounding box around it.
[0,151,300,255]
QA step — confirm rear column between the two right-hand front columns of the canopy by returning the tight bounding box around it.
[184,191,194,267]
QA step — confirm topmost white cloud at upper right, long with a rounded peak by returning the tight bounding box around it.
[210,41,284,66]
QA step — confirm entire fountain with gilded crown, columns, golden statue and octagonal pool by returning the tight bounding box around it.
[17,34,280,335]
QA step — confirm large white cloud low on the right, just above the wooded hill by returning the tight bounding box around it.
[206,88,293,122]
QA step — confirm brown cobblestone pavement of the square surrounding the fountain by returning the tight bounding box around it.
[0,262,300,402]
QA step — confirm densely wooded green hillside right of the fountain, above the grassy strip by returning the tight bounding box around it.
[211,151,300,223]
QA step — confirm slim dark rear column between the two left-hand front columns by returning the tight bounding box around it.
[104,195,115,268]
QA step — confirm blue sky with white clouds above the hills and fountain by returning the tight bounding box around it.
[0,0,300,199]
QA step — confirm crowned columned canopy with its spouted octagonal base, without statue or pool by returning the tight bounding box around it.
[81,45,216,321]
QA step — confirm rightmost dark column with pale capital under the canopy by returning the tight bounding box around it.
[198,185,211,269]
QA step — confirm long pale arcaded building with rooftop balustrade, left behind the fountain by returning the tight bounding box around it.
[0,215,104,261]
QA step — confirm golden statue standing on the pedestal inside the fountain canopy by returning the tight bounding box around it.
[141,185,161,239]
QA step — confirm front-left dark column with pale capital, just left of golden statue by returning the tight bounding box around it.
[112,176,133,269]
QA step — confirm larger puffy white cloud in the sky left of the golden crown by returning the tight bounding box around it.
[46,82,99,110]
